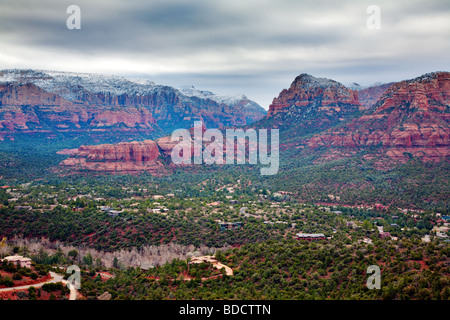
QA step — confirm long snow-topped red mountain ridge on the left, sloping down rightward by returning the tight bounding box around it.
[0,70,266,143]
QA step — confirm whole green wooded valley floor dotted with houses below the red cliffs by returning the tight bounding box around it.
[0,140,450,300]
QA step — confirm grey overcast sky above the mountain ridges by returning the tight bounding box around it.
[0,0,450,109]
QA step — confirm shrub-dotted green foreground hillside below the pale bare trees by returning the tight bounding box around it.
[33,238,450,300]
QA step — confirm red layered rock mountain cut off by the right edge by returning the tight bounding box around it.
[307,72,450,161]
